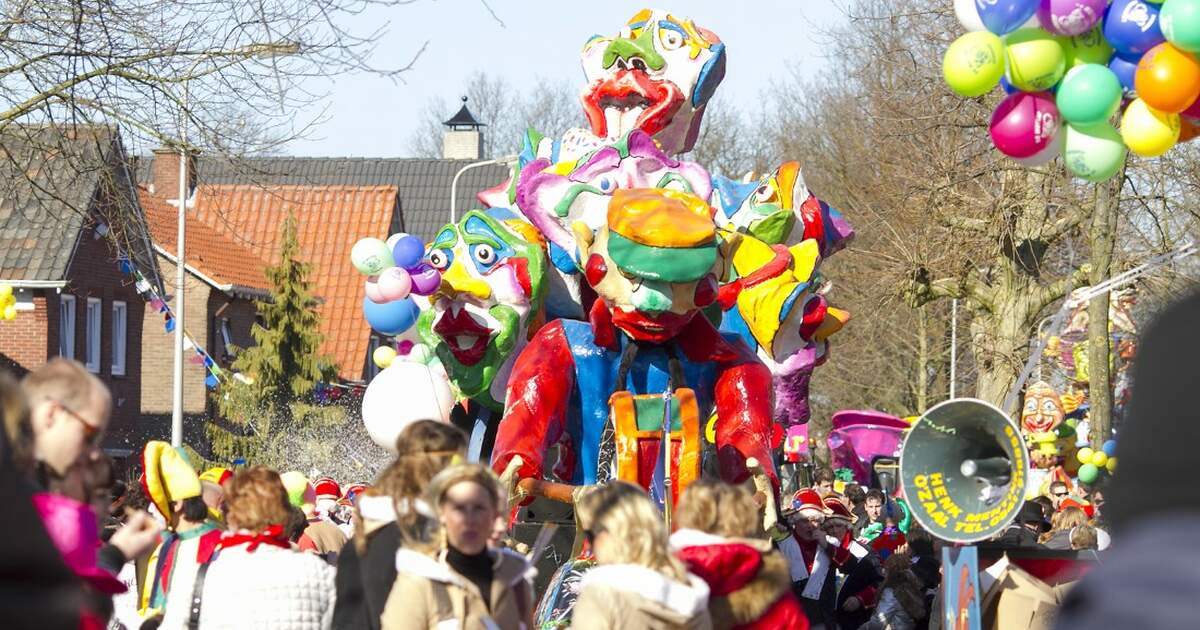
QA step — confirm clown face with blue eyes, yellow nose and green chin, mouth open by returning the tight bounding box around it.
[416,209,545,410]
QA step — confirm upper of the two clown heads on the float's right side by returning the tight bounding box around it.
[713,161,854,257]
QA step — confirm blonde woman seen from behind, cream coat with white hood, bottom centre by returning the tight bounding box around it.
[571,481,713,630]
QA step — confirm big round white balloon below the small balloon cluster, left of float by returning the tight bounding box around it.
[362,361,454,452]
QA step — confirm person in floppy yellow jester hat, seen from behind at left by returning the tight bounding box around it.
[138,440,221,617]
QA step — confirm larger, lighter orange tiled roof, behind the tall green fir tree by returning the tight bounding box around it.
[188,185,398,380]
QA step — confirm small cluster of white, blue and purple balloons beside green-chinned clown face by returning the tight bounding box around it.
[350,234,442,336]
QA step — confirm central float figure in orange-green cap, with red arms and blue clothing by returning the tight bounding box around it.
[492,190,774,491]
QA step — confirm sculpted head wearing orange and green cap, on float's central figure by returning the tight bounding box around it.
[581,188,727,343]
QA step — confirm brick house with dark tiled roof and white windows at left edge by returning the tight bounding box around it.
[0,125,158,456]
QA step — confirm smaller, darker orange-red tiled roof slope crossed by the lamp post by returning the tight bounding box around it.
[138,186,270,290]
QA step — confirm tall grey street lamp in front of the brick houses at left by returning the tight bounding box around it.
[170,42,300,446]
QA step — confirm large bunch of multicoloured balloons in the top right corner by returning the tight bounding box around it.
[942,0,1200,181]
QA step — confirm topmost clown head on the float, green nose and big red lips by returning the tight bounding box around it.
[582,8,725,155]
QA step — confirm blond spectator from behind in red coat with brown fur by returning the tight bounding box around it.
[671,479,809,630]
